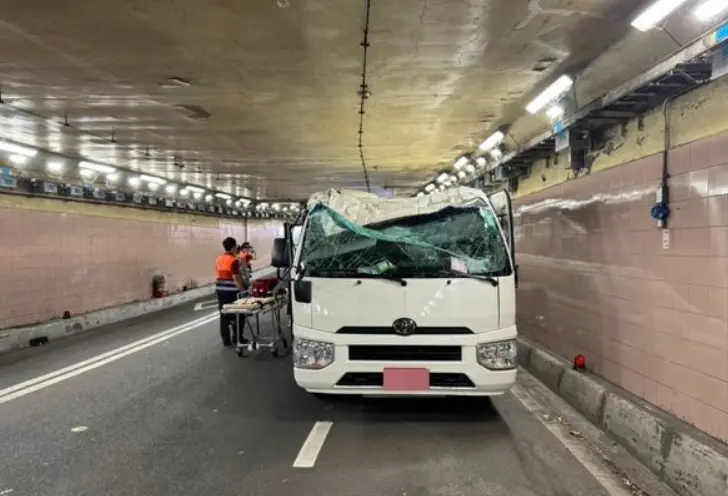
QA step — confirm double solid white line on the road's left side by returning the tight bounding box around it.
[0,312,219,404]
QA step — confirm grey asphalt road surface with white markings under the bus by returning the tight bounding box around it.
[0,298,672,496]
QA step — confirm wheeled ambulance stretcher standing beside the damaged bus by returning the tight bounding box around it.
[220,293,288,357]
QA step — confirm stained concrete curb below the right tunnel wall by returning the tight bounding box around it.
[518,337,728,496]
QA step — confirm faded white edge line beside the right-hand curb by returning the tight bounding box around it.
[511,384,632,496]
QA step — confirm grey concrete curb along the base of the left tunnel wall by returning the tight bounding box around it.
[0,267,275,355]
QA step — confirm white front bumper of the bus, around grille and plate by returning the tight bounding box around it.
[293,325,517,396]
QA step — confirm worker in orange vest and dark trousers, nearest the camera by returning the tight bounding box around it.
[215,238,245,346]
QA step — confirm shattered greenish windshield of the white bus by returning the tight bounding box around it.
[299,205,511,278]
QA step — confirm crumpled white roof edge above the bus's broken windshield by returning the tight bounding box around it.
[307,186,490,226]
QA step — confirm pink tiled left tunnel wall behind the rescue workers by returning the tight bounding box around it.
[0,195,282,329]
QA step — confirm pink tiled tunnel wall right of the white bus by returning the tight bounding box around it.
[516,129,728,441]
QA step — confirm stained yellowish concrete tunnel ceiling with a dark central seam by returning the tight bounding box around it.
[0,0,656,198]
